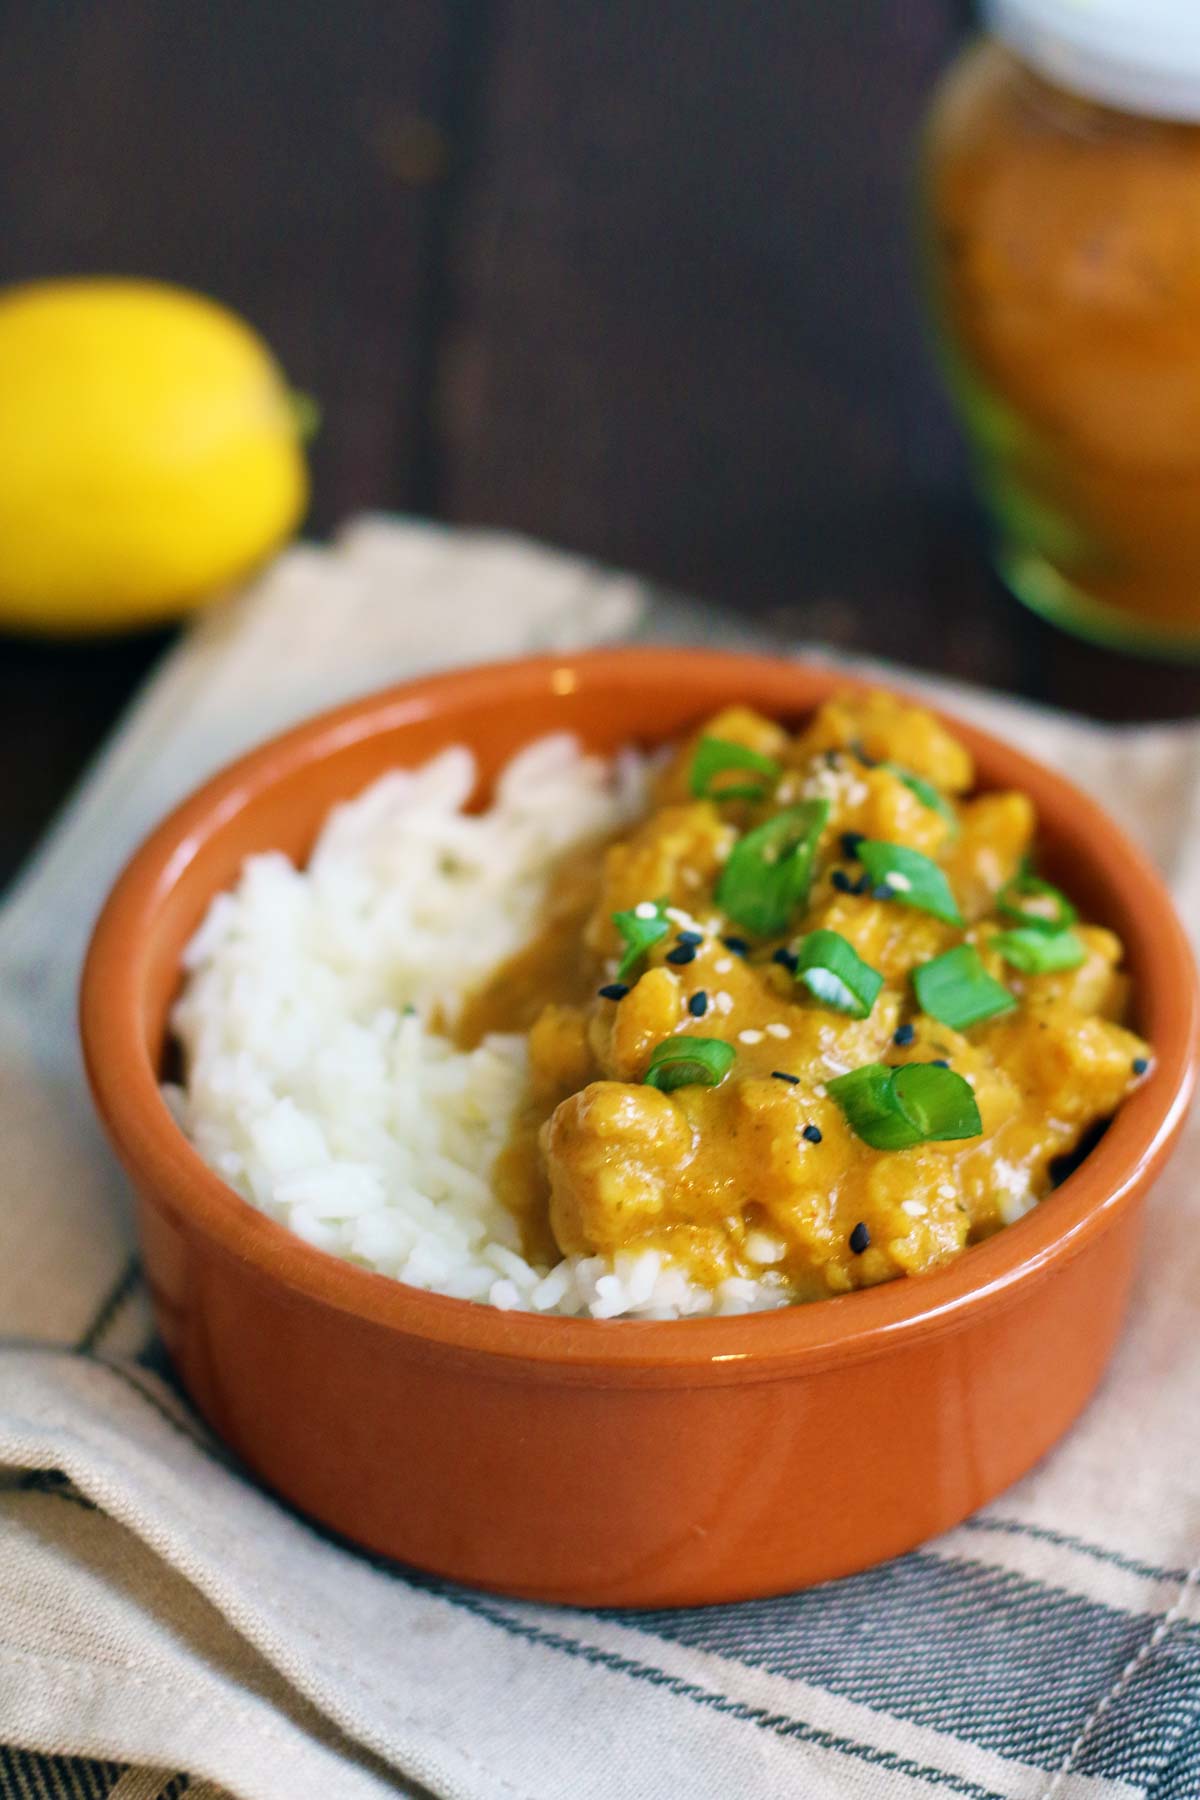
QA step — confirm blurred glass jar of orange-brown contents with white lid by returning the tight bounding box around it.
[921,0,1200,655]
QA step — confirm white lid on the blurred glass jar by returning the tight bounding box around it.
[984,0,1200,121]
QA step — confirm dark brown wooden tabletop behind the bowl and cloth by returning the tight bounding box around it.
[0,0,1200,892]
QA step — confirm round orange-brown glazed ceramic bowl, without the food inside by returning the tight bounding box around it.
[83,650,1196,1606]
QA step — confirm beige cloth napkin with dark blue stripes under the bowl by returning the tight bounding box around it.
[0,520,1200,1800]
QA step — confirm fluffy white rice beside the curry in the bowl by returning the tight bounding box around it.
[167,736,786,1319]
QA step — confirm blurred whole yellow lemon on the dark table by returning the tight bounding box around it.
[0,279,308,634]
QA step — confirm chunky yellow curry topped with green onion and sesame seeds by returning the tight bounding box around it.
[461,693,1150,1300]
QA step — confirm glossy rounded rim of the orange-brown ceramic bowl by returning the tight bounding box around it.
[79,646,1200,1384]
